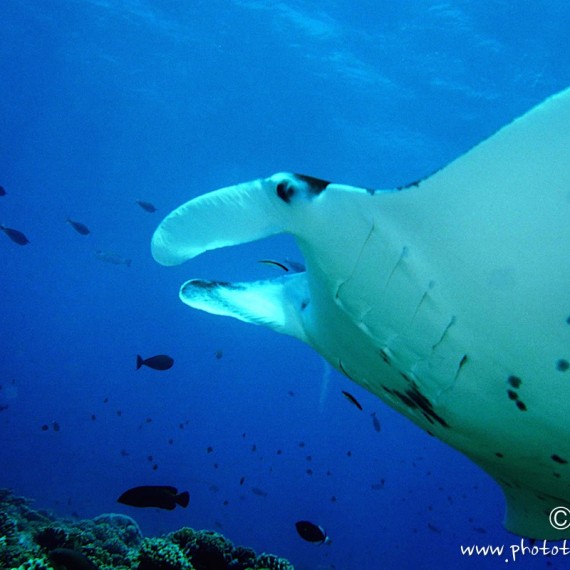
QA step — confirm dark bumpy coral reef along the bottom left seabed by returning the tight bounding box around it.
[0,489,294,570]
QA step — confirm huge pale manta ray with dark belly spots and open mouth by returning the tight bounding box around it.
[152,89,570,539]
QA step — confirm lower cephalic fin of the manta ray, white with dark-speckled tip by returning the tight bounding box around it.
[180,273,309,342]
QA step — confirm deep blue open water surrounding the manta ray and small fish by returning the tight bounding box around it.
[0,0,570,570]
